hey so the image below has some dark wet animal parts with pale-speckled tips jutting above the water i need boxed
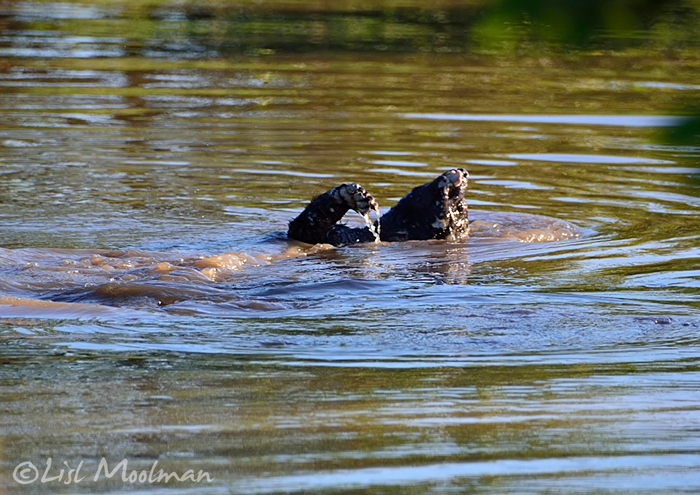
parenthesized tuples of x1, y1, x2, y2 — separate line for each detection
(287, 168, 469, 246)
